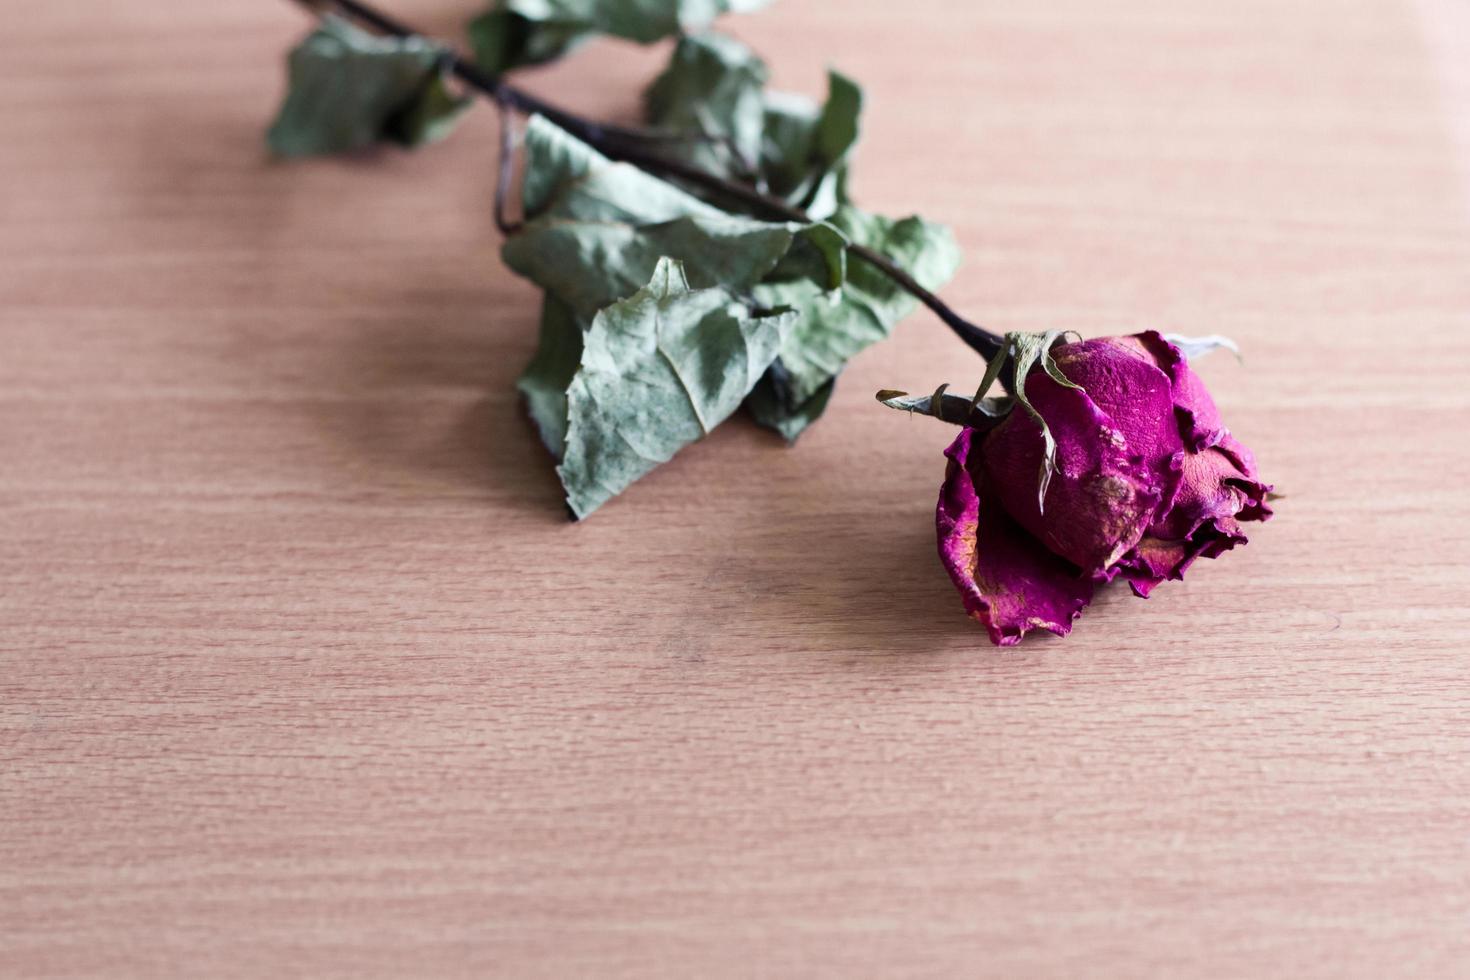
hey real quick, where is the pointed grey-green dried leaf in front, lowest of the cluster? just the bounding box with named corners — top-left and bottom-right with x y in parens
top-left (557, 260), bottom-right (795, 517)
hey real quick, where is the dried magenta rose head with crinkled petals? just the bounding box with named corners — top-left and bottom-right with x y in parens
top-left (934, 332), bottom-right (1272, 646)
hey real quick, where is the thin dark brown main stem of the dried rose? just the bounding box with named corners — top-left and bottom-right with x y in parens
top-left (285, 0), bottom-right (1005, 360)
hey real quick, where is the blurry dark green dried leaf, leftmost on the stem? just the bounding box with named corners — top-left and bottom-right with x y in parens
top-left (266, 18), bottom-right (469, 157)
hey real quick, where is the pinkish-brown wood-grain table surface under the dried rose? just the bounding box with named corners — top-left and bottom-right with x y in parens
top-left (0, 0), bottom-right (1470, 977)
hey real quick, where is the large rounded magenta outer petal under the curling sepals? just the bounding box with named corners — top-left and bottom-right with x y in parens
top-left (985, 338), bottom-right (1183, 579)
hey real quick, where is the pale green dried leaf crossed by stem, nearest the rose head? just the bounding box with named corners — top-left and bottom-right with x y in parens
top-left (754, 207), bottom-right (960, 433)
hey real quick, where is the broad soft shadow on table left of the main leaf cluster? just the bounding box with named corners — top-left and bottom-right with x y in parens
top-left (119, 100), bottom-right (566, 525)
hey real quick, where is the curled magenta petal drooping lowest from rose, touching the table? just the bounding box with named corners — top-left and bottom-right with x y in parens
top-left (935, 429), bottom-right (1092, 646)
